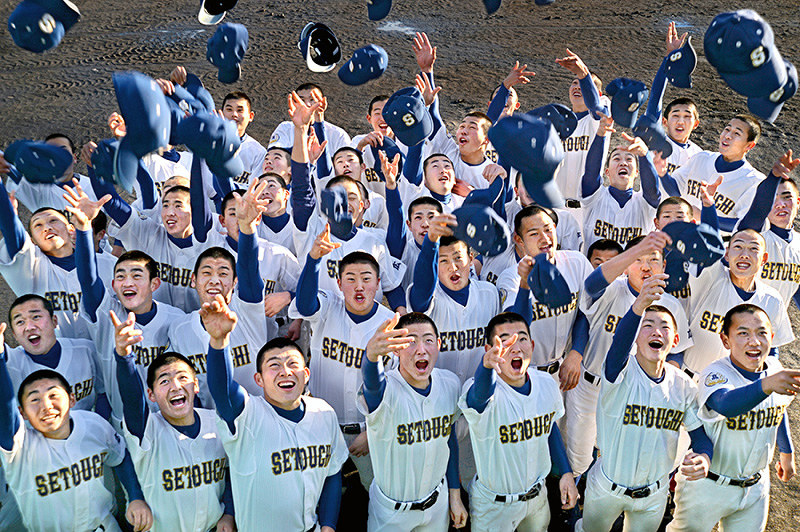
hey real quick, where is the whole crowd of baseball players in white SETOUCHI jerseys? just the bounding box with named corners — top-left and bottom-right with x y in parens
top-left (0, 25), bottom-right (800, 532)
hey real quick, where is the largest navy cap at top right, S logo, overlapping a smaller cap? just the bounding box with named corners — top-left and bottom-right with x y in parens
top-left (703, 9), bottom-right (787, 98)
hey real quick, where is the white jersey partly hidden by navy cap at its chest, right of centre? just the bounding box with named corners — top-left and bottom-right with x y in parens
top-left (497, 250), bottom-right (592, 366)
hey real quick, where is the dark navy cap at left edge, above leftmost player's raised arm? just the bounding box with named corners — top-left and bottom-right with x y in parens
top-left (3, 140), bottom-right (73, 183)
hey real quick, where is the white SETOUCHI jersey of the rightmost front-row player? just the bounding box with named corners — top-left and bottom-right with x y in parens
top-left (698, 356), bottom-right (794, 479)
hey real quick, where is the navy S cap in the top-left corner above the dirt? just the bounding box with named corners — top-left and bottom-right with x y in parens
top-left (8, 0), bottom-right (81, 53)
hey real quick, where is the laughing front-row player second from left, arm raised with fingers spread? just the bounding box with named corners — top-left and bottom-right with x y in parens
top-left (110, 310), bottom-right (234, 532)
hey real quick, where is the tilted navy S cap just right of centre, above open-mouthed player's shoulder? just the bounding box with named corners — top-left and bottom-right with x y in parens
top-left (453, 203), bottom-right (511, 257)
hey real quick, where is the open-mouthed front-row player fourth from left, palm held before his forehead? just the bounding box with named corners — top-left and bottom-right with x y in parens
top-left (358, 312), bottom-right (467, 532)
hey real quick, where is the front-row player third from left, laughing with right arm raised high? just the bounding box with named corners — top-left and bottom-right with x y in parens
top-left (201, 295), bottom-right (347, 532)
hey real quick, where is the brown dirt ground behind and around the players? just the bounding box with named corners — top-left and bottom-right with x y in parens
top-left (0, 0), bottom-right (800, 531)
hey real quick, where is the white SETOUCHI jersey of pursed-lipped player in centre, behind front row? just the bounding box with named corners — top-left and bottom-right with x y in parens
top-left (289, 290), bottom-right (394, 424)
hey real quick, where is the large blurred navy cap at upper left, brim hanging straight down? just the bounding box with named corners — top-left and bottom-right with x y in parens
top-left (112, 72), bottom-right (171, 192)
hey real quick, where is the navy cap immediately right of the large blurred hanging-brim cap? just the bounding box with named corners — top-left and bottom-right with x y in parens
top-left (176, 112), bottom-right (244, 178)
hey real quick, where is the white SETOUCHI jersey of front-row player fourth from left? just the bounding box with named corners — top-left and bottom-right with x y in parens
top-left (358, 368), bottom-right (461, 501)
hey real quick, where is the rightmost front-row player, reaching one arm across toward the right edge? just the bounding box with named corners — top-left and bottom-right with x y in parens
top-left (667, 303), bottom-right (800, 532)
